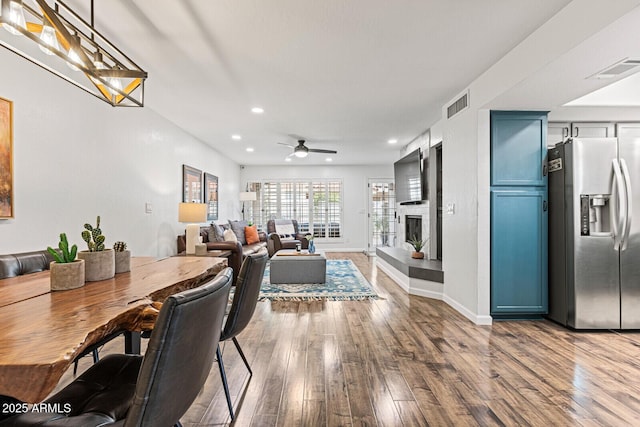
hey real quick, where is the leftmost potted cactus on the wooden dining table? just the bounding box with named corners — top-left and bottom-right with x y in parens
top-left (47, 233), bottom-right (84, 291)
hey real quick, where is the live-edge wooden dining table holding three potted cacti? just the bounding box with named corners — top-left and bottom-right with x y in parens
top-left (0, 257), bottom-right (226, 403)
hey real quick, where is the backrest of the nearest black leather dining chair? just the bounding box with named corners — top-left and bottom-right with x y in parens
top-left (124, 268), bottom-right (233, 427)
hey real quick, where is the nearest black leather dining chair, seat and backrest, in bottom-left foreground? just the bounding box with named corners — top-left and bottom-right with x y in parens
top-left (0, 268), bottom-right (233, 427)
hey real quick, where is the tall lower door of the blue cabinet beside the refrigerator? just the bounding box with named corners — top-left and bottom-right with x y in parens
top-left (491, 189), bottom-right (548, 317)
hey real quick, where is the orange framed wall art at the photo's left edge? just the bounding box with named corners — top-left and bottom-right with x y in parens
top-left (0, 98), bottom-right (14, 219)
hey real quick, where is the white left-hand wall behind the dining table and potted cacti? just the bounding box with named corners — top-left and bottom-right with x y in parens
top-left (0, 49), bottom-right (240, 257)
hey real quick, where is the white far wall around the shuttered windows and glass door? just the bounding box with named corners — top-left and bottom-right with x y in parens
top-left (240, 163), bottom-right (396, 251)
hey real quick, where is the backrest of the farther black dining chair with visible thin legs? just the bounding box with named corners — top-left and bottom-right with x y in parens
top-left (220, 249), bottom-right (269, 341)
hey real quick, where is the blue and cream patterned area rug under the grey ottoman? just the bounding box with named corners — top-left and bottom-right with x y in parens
top-left (259, 259), bottom-right (379, 301)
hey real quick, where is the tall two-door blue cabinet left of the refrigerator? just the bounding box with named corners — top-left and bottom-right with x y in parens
top-left (491, 111), bottom-right (548, 318)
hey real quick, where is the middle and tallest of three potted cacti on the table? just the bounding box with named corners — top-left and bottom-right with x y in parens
top-left (78, 215), bottom-right (116, 282)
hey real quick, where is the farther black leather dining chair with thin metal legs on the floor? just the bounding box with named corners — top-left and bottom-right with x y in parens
top-left (216, 250), bottom-right (269, 421)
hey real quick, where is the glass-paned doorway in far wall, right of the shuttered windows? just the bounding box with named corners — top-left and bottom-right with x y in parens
top-left (367, 179), bottom-right (396, 255)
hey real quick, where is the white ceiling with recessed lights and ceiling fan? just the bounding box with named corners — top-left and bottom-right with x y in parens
top-left (66, 0), bottom-right (569, 165)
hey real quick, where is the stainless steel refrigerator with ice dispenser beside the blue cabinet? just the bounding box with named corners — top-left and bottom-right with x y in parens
top-left (548, 138), bottom-right (640, 329)
